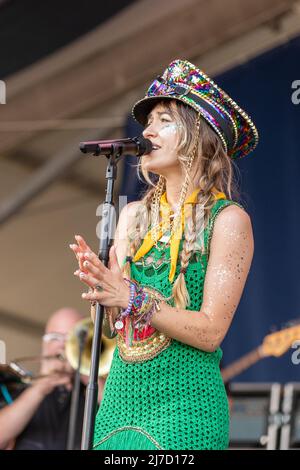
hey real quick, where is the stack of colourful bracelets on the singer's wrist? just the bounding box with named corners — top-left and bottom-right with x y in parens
top-left (113, 278), bottom-right (162, 347)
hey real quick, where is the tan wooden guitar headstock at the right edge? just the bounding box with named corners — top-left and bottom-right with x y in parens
top-left (260, 325), bottom-right (300, 357)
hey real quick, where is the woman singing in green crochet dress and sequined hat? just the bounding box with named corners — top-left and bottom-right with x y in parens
top-left (71, 60), bottom-right (258, 450)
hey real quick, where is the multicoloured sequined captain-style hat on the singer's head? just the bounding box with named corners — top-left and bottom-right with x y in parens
top-left (132, 59), bottom-right (258, 159)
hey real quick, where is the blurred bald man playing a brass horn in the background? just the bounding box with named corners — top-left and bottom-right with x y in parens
top-left (0, 308), bottom-right (85, 450)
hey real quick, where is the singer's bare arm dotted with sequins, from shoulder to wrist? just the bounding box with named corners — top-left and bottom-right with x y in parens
top-left (151, 206), bottom-right (254, 352)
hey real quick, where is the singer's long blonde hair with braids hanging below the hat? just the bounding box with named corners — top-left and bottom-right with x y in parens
top-left (123, 100), bottom-right (239, 309)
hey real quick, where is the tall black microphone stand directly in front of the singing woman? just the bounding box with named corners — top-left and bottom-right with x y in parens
top-left (81, 144), bottom-right (121, 450)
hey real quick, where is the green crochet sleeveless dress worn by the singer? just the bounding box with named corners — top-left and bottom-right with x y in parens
top-left (94, 199), bottom-right (241, 450)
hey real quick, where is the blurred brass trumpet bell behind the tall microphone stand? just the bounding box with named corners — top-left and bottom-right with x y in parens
top-left (65, 317), bottom-right (116, 377)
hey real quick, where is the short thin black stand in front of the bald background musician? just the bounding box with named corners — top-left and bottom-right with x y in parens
top-left (67, 328), bottom-right (88, 450)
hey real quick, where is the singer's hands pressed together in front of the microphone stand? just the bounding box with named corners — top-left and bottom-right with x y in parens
top-left (70, 235), bottom-right (129, 309)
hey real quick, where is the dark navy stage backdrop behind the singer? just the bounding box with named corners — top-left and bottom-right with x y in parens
top-left (122, 37), bottom-right (300, 382)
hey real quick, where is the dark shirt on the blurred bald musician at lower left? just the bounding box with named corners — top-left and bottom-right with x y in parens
top-left (15, 384), bottom-right (85, 450)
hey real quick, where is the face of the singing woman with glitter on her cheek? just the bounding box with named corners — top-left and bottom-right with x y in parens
top-left (142, 104), bottom-right (181, 177)
